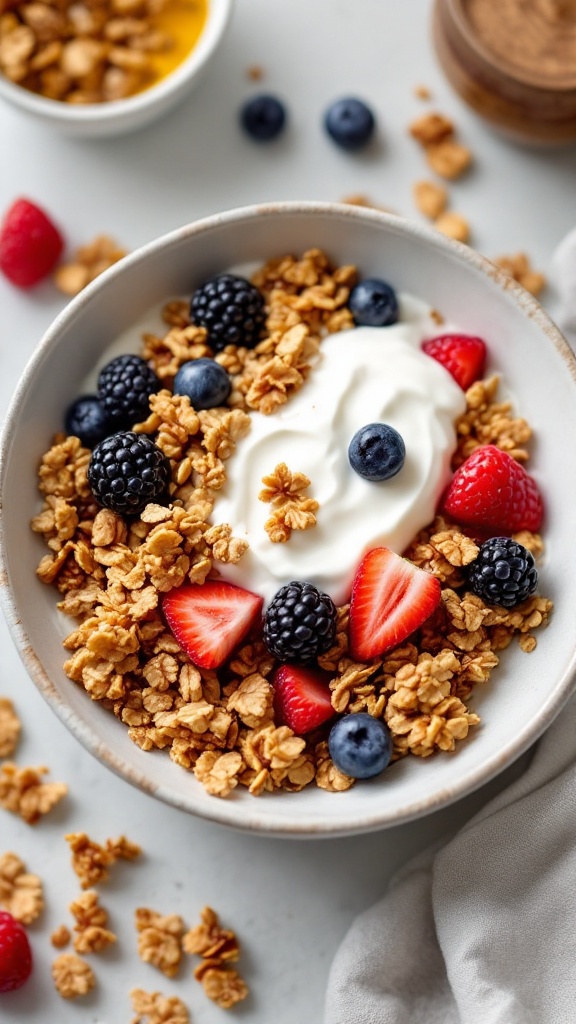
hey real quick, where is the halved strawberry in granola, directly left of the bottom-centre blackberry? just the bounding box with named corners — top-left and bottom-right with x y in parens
top-left (162, 580), bottom-right (262, 669)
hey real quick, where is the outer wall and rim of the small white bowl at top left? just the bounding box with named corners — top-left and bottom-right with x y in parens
top-left (0, 0), bottom-right (232, 138)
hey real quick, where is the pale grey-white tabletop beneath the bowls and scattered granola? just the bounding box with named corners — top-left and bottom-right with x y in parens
top-left (0, 0), bottom-right (576, 1024)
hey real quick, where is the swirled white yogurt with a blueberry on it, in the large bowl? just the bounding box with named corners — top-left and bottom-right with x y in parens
top-left (212, 296), bottom-right (465, 604)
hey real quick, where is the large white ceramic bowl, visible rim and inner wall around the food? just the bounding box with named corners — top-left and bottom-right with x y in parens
top-left (0, 203), bottom-right (576, 837)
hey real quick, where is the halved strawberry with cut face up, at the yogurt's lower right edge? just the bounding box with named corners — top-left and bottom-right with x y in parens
top-left (349, 548), bottom-right (440, 662)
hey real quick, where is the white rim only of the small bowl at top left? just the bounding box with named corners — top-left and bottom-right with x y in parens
top-left (0, 0), bottom-right (234, 130)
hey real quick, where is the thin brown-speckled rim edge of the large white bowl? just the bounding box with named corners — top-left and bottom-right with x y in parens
top-left (0, 195), bottom-right (576, 839)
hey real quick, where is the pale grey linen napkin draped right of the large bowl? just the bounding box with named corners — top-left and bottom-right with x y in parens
top-left (325, 230), bottom-right (576, 1024)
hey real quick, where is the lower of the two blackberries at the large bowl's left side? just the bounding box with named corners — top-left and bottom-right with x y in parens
top-left (88, 430), bottom-right (170, 515)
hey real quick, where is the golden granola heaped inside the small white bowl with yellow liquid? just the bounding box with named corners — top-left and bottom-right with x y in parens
top-left (0, 0), bottom-right (201, 103)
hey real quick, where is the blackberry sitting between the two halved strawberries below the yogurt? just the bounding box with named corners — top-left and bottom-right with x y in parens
top-left (263, 580), bottom-right (336, 665)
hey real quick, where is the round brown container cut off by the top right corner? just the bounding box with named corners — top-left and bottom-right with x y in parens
top-left (433, 0), bottom-right (576, 143)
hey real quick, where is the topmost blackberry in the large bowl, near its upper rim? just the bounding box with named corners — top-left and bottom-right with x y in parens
top-left (190, 273), bottom-right (265, 352)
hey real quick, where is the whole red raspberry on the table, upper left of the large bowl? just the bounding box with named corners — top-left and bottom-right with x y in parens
top-left (0, 199), bottom-right (64, 288)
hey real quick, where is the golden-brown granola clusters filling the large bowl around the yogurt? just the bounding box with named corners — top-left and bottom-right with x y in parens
top-left (32, 251), bottom-right (551, 794)
